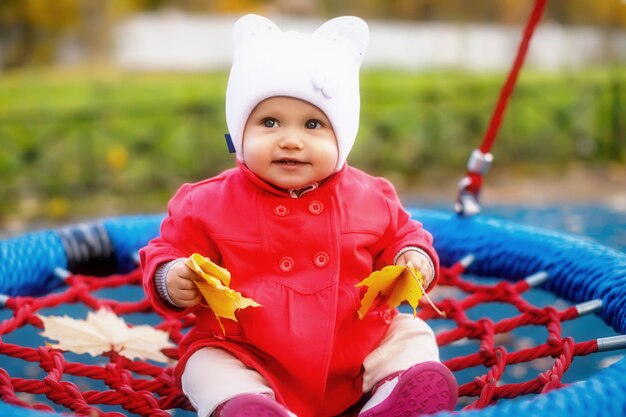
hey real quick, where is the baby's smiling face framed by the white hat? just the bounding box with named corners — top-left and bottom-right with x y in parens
top-left (243, 97), bottom-right (339, 189)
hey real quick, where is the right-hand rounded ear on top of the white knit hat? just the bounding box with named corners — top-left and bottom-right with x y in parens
top-left (314, 16), bottom-right (370, 63)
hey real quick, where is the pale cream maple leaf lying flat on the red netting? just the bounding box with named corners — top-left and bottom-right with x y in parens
top-left (38, 308), bottom-right (174, 362)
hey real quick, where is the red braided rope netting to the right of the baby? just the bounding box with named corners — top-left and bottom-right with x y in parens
top-left (420, 263), bottom-right (598, 409)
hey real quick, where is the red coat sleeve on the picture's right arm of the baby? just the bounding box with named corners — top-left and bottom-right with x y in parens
top-left (374, 178), bottom-right (439, 290)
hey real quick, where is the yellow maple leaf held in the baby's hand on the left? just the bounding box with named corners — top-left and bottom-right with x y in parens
top-left (187, 253), bottom-right (261, 333)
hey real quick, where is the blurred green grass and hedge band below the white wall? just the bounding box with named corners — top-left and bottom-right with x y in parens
top-left (0, 70), bottom-right (626, 229)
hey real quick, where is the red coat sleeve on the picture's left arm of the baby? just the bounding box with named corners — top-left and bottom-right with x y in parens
top-left (139, 184), bottom-right (219, 315)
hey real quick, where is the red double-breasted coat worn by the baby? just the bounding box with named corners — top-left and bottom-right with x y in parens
top-left (141, 165), bottom-right (439, 417)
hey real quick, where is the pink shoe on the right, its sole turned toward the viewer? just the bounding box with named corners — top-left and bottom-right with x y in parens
top-left (359, 362), bottom-right (459, 417)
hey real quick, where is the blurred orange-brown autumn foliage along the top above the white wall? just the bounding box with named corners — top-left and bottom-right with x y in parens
top-left (0, 0), bottom-right (626, 69)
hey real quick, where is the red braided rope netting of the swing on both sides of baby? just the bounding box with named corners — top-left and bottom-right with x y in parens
top-left (0, 256), bottom-right (598, 417)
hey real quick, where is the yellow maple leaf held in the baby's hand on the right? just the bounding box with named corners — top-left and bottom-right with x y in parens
top-left (356, 265), bottom-right (424, 319)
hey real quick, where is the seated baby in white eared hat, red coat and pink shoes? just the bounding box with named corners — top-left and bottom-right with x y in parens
top-left (141, 15), bottom-right (457, 417)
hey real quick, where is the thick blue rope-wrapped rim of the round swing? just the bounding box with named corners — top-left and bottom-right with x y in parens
top-left (0, 209), bottom-right (626, 417)
